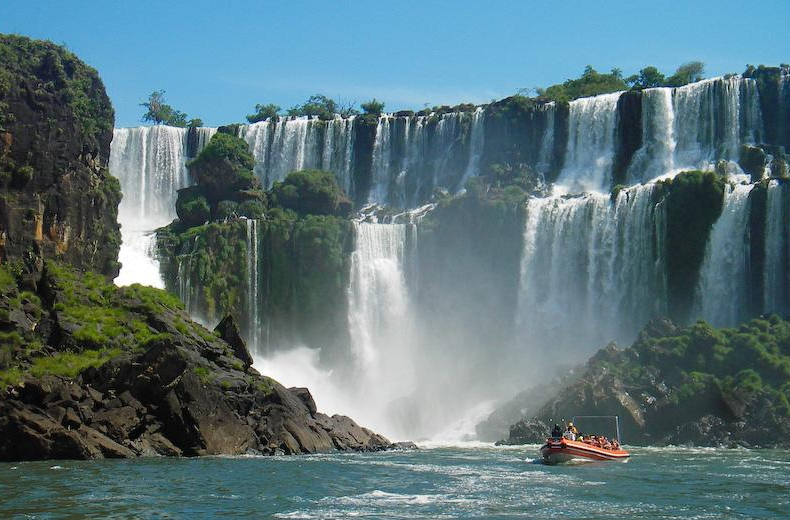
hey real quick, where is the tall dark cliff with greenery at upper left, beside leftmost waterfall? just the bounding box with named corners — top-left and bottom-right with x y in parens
top-left (0, 36), bottom-right (120, 277)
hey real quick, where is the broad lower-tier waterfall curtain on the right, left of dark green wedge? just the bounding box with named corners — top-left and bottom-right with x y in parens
top-left (517, 185), bottom-right (666, 361)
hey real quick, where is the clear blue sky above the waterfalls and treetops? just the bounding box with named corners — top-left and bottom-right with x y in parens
top-left (0, 0), bottom-right (790, 126)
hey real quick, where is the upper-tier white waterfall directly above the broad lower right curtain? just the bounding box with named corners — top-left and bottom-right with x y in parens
top-left (557, 92), bottom-right (622, 193)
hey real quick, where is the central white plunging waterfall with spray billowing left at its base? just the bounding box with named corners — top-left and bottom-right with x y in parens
top-left (260, 222), bottom-right (419, 437)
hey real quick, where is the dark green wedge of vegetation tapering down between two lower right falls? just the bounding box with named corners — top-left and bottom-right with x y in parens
top-left (661, 171), bottom-right (725, 322)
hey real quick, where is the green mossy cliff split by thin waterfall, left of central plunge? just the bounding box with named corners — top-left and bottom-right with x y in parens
top-left (157, 167), bottom-right (353, 345)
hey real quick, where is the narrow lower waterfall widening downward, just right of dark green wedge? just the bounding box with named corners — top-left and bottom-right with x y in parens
top-left (695, 184), bottom-right (753, 327)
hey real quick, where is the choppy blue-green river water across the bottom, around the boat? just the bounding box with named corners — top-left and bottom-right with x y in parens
top-left (0, 445), bottom-right (790, 520)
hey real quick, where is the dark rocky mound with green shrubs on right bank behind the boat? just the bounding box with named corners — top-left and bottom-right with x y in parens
top-left (506, 316), bottom-right (790, 447)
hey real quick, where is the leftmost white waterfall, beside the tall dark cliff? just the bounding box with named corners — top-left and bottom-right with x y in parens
top-left (109, 126), bottom-right (188, 287)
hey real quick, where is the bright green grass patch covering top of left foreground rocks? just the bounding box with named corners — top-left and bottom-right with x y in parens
top-left (0, 261), bottom-right (201, 387)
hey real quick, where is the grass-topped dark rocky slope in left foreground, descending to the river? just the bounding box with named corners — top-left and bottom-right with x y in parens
top-left (0, 261), bottom-right (390, 460)
